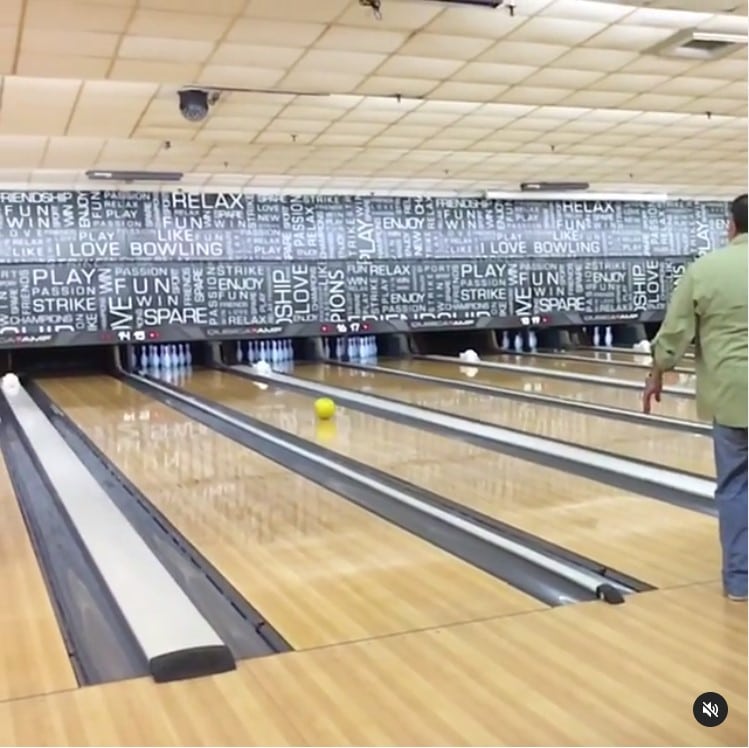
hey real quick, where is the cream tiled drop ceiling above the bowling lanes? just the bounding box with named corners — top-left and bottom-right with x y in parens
top-left (0, 0), bottom-right (747, 196)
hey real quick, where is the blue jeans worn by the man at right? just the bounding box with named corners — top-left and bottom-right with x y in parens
top-left (713, 423), bottom-right (747, 596)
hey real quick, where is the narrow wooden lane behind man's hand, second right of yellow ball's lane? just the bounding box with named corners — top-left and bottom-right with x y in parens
top-left (380, 359), bottom-right (699, 421)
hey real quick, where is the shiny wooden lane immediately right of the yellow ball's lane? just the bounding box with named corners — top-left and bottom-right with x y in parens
top-left (294, 364), bottom-right (715, 477)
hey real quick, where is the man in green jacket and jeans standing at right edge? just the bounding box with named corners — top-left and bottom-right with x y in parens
top-left (642, 195), bottom-right (748, 601)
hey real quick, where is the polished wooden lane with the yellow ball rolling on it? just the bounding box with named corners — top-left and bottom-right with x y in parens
top-left (183, 367), bottom-right (719, 586)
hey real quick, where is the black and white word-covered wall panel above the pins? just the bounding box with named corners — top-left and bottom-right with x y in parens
top-left (0, 192), bottom-right (727, 346)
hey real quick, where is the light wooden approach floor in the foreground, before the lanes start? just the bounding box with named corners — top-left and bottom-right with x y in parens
top-left (0, 585), bottom-right (747, 746)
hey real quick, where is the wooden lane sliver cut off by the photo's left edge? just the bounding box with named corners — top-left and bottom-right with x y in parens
top-left (0, 457), bottom-right (76, 701)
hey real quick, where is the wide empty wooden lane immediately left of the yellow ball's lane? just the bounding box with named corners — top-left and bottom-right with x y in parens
top-left (41, 377), bottom-right (543, 648)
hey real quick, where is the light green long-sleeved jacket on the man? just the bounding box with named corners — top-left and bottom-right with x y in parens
top-left (652, 234), bottom-right (749, 428)
